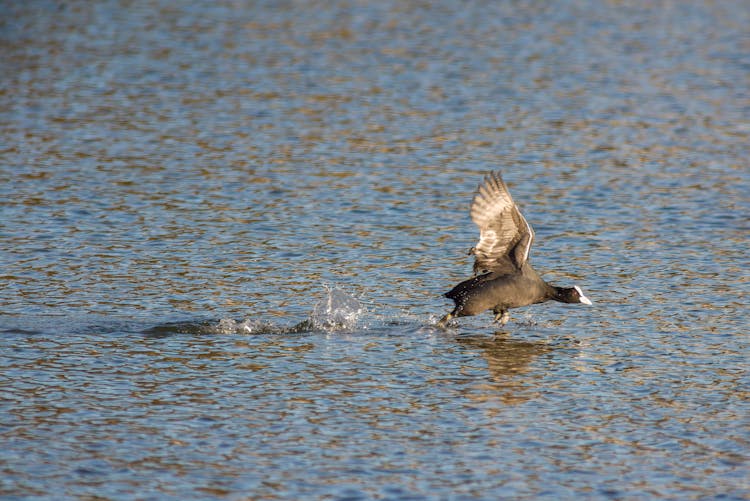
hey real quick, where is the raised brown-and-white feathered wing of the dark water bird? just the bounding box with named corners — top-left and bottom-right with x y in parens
top-left (471, 172), bottom-right (534, 274)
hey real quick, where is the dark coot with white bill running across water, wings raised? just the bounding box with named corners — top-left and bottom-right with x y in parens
top-left (438, 172), bottom-right (591, 327)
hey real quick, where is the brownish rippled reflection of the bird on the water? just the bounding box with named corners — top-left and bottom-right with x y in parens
top-left (456, 331), bottom-right (554, 404)
